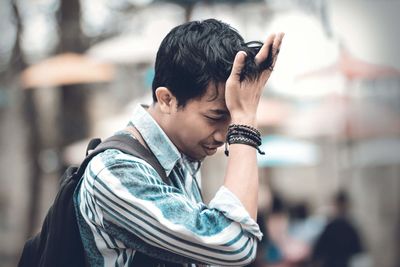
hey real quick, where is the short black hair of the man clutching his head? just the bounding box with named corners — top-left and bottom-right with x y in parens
top-left (152, 19), bottom-right (272, 107)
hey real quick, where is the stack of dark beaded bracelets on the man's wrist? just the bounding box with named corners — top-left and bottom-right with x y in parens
top-left (225, 124), bottom-right (265, 156)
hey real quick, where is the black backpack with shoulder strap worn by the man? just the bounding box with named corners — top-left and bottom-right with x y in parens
top-left (18, 135), bottom-right (182, 267)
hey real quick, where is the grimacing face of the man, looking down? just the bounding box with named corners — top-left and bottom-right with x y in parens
top-left (169, 84), bottom-right (230, 160)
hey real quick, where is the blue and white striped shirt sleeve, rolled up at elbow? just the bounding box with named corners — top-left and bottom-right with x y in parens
top-left (84, 150), bottom-right (262, 266)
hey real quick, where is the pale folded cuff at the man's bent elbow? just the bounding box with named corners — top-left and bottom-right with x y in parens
top-left (209, 186), bottom-right (263, 240)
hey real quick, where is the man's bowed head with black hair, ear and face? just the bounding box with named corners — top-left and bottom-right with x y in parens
top-left (148, 19), bottom-right (261, 160)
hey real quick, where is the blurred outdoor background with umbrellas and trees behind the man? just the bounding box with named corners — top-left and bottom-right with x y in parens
top-left (0, 0), bottom-right (400, 267)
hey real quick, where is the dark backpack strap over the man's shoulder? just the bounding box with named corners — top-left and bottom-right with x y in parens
top-left (76, 134), bottom-right (170, 185)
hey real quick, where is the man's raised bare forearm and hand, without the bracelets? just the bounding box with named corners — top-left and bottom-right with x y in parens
top-left (224, 33), bottom-right (284, 219)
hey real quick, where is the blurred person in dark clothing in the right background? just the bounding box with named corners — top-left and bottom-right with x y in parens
top-left (313, 191), bottom-right (363, 267)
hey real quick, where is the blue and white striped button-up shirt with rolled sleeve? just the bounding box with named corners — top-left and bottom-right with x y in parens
top-left (75, 106), bottom-right (262, 266)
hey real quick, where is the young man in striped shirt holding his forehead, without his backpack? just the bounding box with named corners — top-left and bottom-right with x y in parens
top-left (76, 19), bottom-right (283, 266)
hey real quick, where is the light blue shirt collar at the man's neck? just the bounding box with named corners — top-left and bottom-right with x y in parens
top-left (130, 105), bottom-right (182, 176)
